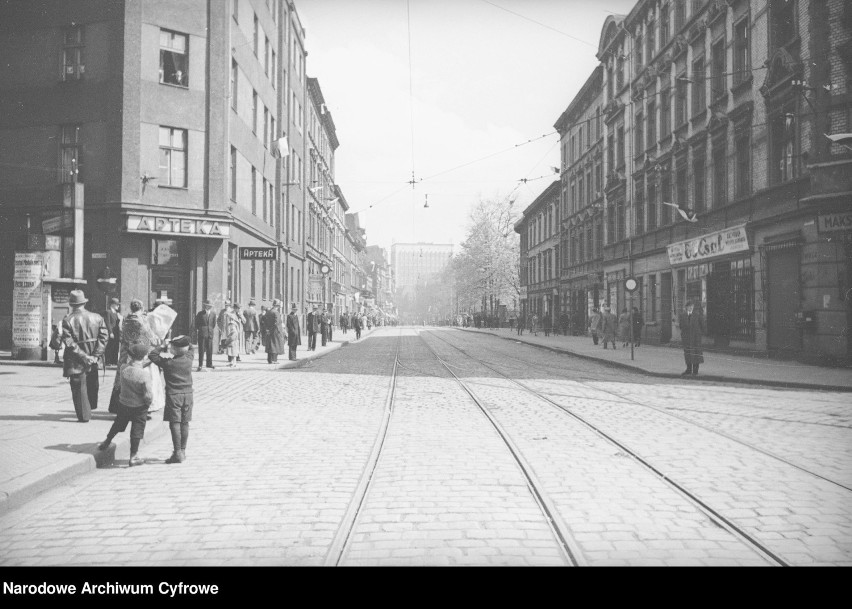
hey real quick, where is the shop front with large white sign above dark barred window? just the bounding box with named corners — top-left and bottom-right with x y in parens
top-left (668, 224), bottom-right (756, 349)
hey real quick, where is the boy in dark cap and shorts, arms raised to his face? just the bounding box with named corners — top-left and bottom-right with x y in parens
top-left (148, 336), bottom-right (195, 463)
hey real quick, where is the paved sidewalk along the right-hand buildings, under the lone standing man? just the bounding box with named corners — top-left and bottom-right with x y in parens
top-left (459, 328), bottom-right (852, 391)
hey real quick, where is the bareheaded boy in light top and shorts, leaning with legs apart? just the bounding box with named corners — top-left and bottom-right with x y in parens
top-left (98, 342), bottom-right (154, 467)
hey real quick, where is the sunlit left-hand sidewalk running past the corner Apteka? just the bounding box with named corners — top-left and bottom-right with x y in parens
top-left (0, 328), bottom-right (375, 517)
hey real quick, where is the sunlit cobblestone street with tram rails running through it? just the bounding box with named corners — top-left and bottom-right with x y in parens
top-left (0, 327), bottom-right (852, 566)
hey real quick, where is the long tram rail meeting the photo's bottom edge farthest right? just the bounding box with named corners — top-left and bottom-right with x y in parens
top-left (424, 331), bottom-right (792, 566)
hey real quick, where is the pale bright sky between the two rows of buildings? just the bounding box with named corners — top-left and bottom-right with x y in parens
top-left (296, 0), bottom-right (635, 256)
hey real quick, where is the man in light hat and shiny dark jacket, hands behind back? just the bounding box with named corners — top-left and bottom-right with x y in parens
top-left (62, 290), bottom-right (109, 423)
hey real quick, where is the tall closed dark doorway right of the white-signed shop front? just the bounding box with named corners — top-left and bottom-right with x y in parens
top-left (767, 248), bottom-right (802, 351)
